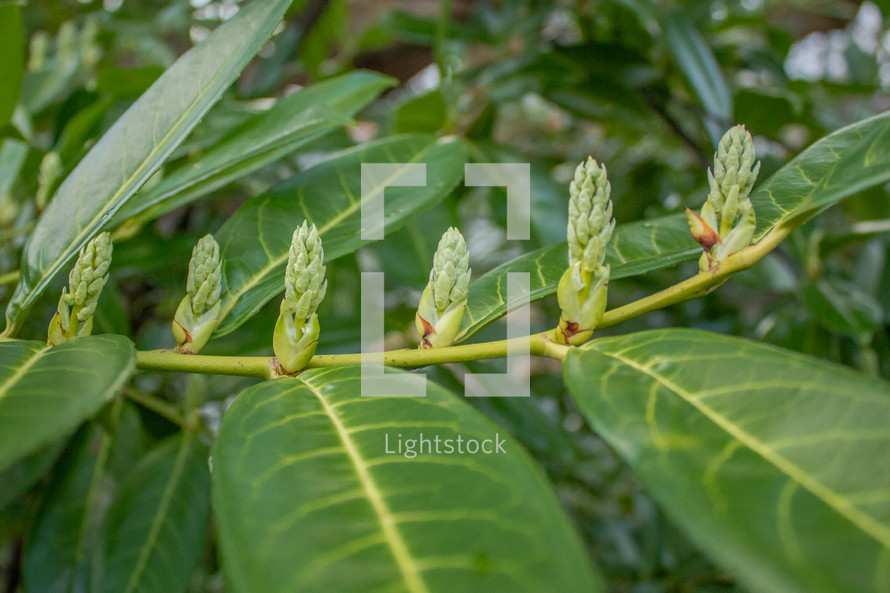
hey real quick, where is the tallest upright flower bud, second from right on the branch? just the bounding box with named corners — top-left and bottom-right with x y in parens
top-left (556, 157), bottom-right (615, 344)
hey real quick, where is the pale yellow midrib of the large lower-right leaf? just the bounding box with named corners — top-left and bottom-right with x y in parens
top-left (597, 350), bottom-right (890, 548)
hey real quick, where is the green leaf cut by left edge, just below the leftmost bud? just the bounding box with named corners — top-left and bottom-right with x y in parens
top-left (0, 335), bottom-right (136, 470)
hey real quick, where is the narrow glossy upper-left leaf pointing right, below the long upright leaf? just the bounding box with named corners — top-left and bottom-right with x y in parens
top-left (110, 71), bottom-right (395, 226)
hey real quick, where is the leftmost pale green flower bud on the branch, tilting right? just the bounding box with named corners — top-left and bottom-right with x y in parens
top-left (47, 233), bottom-right (113, 346)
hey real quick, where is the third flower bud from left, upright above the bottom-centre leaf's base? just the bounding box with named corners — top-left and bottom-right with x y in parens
top-left (272, 221), bottom-right (328, 375)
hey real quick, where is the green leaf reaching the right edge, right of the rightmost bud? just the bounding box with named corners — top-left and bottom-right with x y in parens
top-left (751, 112), bottom-right (890, 239)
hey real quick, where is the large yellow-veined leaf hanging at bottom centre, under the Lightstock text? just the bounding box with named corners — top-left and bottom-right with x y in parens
top-left (213, 366), bottom-right (599, 593)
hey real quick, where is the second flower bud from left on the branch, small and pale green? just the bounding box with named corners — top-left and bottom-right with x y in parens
top-left (173, 234), bottom-right (222, 354)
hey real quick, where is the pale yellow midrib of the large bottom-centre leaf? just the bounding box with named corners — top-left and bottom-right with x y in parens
top-left (300, 379), bottom-right (430, 593)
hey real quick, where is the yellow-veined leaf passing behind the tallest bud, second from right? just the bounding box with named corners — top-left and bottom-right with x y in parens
top-left (456, 215), bottom-right (701, 342)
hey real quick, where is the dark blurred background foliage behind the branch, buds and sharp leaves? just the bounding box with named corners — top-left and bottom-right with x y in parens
top-left (0, 0), bottom-right (890, 593)
